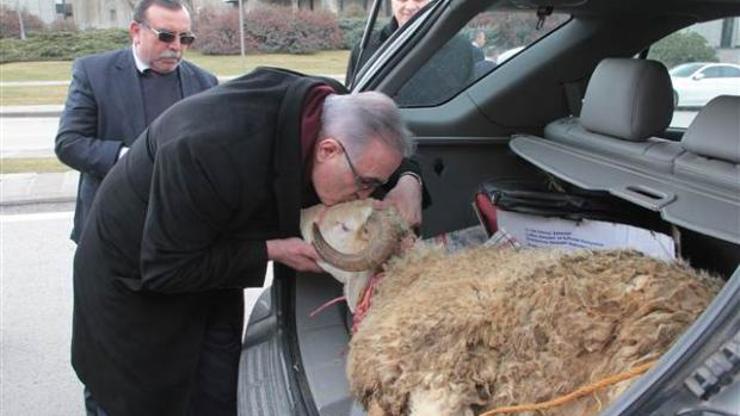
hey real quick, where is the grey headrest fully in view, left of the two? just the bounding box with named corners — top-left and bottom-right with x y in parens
top-left (581, 58), bottom-right (673, 142)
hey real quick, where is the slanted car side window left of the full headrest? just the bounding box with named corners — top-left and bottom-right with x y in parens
top-left (394, 11), bottom-right (569, 107)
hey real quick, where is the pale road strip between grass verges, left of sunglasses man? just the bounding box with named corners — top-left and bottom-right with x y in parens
top-left (0, 117), bottom-right (59, 158)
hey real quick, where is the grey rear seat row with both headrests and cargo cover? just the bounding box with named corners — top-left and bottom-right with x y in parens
top-left (509, 59), bottom-right (740, 244)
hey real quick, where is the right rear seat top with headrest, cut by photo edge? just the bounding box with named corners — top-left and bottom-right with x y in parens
top-left (673, 95), bottom-right (740, 191)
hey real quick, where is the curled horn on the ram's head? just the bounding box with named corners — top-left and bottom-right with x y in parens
top-left (312, 208), bottom-right (406, 272)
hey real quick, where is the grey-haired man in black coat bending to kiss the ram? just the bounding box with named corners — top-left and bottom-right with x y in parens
top-left (72, 69), bottom-right (421, 416)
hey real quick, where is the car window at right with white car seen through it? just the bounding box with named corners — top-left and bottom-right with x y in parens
top-left (648, 16), bottom-right (740, 128)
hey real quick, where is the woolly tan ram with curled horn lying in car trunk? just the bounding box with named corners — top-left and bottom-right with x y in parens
top-left (302, 202), bottom-right (721, 416)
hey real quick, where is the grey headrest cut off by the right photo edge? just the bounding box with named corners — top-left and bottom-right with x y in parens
top-left (681, 95), bottom-right (740, 163)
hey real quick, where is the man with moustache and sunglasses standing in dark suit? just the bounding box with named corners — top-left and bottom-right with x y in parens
top-left (55, 0), bottom-right (217, 242)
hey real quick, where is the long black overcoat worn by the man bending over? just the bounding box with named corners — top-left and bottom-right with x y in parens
top-left (72, 68), bottom-right (343, 416)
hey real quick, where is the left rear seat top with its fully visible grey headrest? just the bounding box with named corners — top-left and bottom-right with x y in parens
top-left (545, 58), bottom-right (684, 173)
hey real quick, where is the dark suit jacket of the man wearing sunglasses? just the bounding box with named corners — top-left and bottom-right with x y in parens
top-left (55, 48), bottom-right (217, 241)
